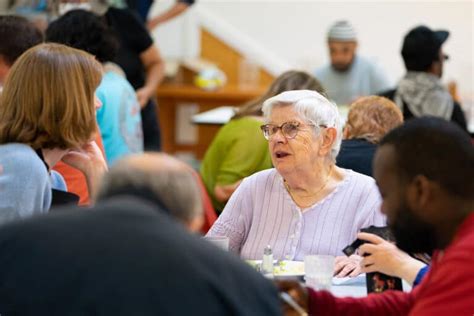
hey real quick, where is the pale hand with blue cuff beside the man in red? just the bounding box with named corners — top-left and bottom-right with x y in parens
top-left (357, 233), bottom-right (425, 284)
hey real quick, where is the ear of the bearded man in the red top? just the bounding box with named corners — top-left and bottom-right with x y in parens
top-left (406, 175), bottom-right (435, 215)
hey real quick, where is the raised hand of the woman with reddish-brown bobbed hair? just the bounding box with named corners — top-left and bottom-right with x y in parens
top-left (62, 141), bottom-right (107, 197)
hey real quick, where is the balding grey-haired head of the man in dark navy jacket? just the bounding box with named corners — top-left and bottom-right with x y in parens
top-left (97, 153), bottom-right (203, 232)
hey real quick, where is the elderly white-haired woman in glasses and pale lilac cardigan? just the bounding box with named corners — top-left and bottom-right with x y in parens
top-left (208, 90), bottom-right (385, 276)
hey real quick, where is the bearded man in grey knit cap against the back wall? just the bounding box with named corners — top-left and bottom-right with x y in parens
top-left (315, 21), bottom-right (390, 105)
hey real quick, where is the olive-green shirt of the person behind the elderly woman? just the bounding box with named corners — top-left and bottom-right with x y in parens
top-left (200, 117), bottom-right (272, 212)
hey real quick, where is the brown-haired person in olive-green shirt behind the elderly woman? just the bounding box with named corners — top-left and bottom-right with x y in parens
top-left (200, 71), bottom-right (323, 213)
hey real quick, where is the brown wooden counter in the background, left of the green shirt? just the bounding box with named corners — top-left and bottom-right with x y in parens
top-left (157, 84), bottom-right (266, 159)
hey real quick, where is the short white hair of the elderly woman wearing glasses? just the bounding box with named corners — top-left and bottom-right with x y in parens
top-left (262, 90), bottom-right (342, 161)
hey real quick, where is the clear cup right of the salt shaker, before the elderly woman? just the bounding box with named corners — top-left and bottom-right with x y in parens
top-left (304, 255), bottom-right (335, 291)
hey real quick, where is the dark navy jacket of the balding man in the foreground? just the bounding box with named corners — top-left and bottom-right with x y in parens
top-left (0, 197), bottom-right (281, 316)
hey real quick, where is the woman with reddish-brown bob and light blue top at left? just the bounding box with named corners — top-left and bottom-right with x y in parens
top-left (0, 44), bottom-right (107, 224)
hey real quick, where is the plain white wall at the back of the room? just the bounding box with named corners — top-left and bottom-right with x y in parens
top-left (150, 0), bottom-right (474, 101)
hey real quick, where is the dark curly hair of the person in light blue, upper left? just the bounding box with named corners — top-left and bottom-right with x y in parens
top-left (46, 10), bottom-right (119, 63)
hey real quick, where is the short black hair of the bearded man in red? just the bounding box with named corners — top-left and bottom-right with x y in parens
top-left (380, 117), bottom-right (474, 198)
